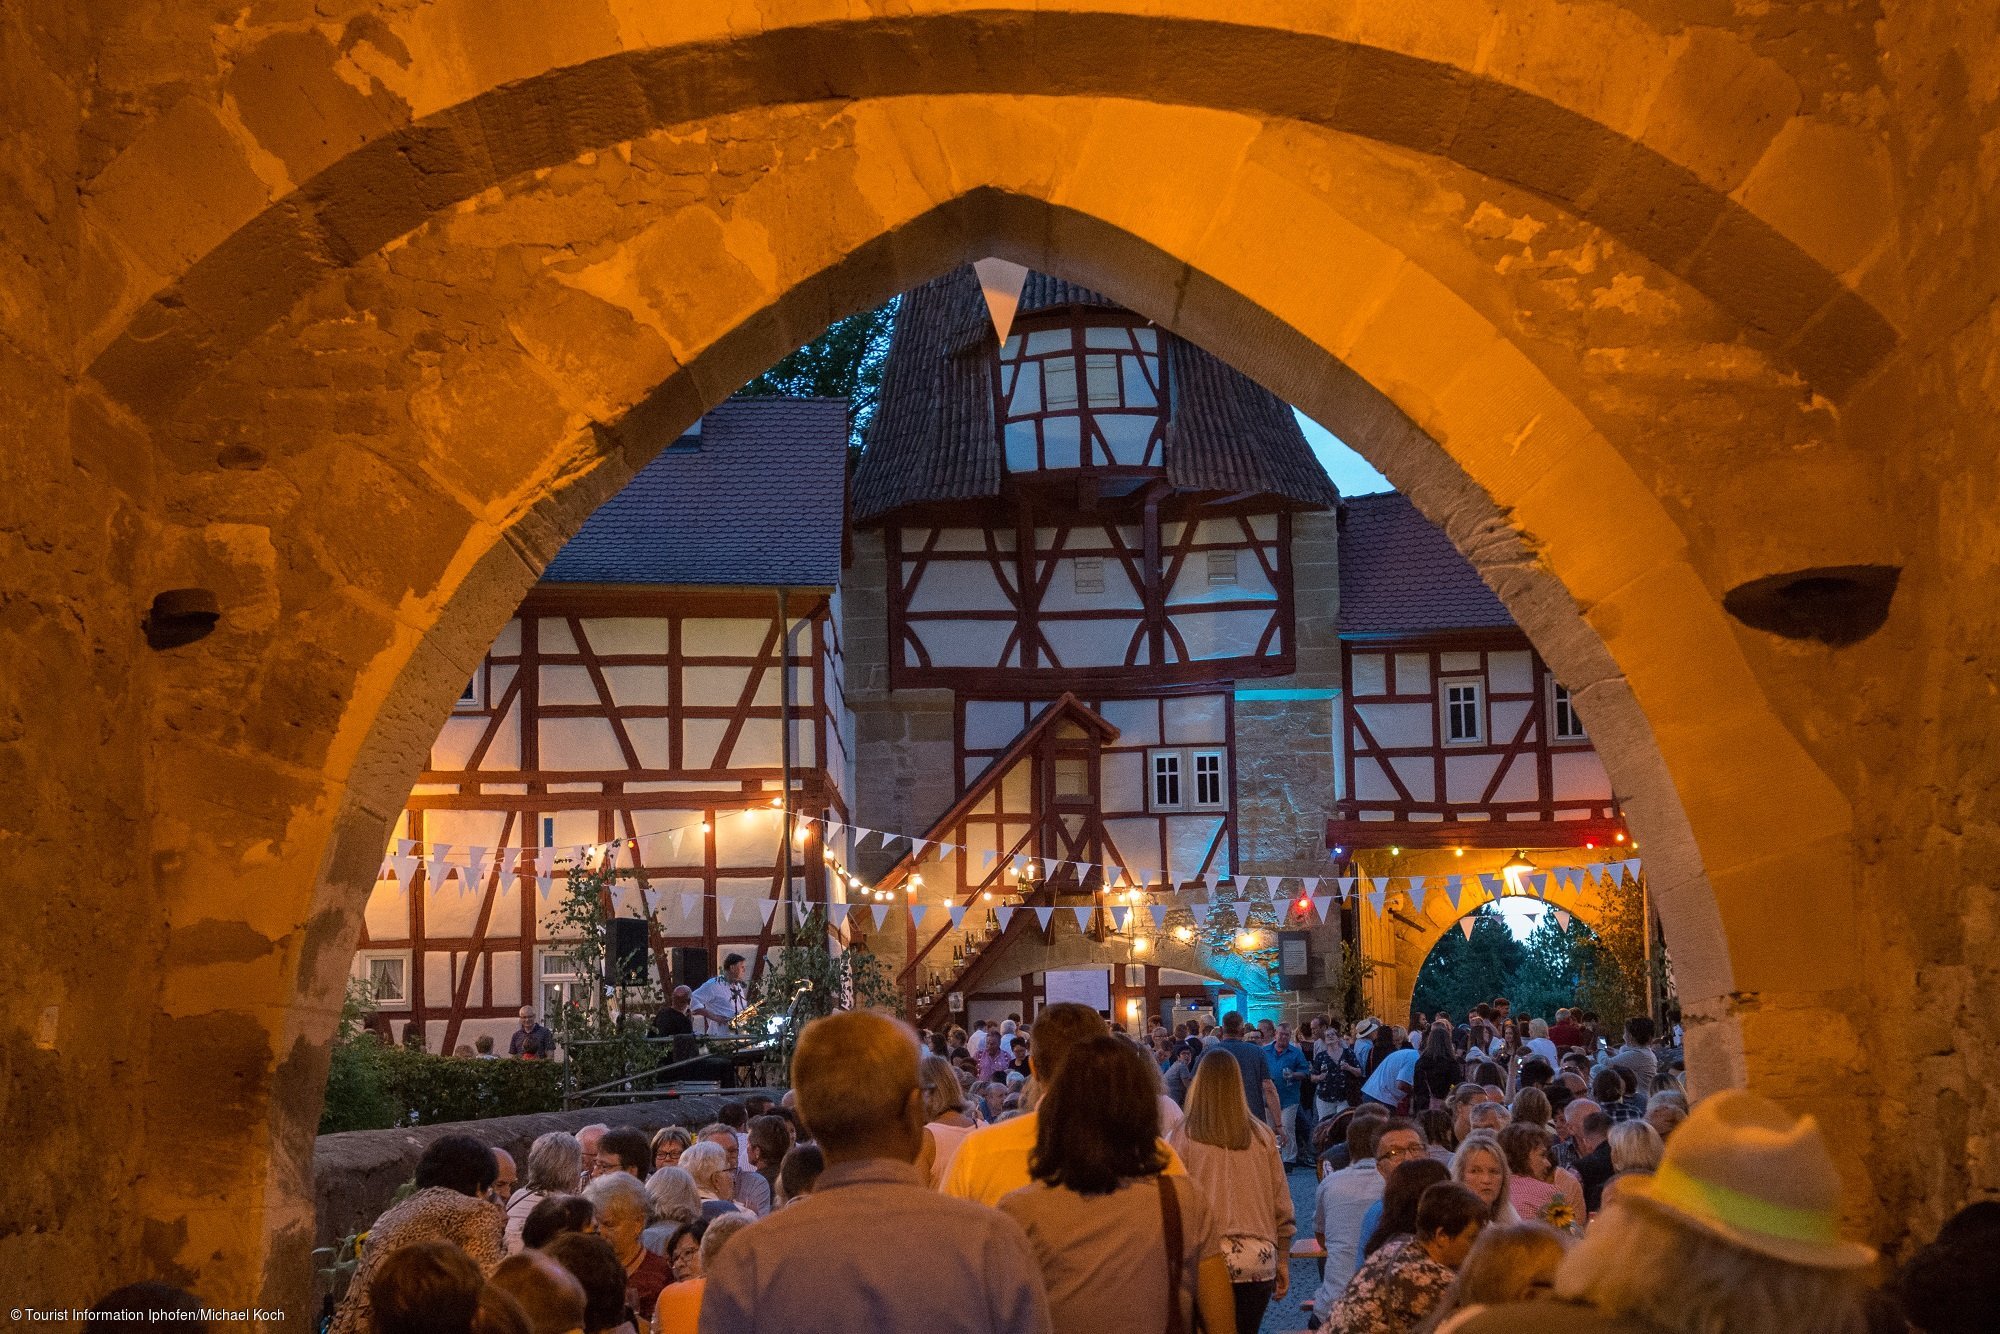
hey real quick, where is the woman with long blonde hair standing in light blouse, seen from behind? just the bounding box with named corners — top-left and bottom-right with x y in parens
top-left (1166, 1052), bottom-right (1294, 1334)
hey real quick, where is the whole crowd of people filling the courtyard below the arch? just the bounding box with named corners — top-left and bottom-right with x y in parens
top-left (94, 1002), bottom-right (2000, 1334)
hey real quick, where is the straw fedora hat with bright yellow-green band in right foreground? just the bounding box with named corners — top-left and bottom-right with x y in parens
top-left (1618, 1090), bottom-right (1876, 1268)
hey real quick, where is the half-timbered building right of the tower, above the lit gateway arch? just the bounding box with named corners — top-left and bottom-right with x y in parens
top-left (1326, 492), bottom-right (1628, 1014)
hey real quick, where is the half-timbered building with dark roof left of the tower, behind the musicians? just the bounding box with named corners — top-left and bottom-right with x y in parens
top-left (354, 398), bottom-right (848, 1050)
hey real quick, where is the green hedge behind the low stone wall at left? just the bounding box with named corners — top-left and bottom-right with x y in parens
top-left (320, 1034), bottom-right (562, 1134)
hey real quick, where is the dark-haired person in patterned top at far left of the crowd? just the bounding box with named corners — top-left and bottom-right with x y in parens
top-left (328, 1134), bottom-right (506, 1334)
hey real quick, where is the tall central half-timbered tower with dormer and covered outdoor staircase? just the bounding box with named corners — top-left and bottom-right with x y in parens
top-left (844, 270), bottom-right (1340, 1022)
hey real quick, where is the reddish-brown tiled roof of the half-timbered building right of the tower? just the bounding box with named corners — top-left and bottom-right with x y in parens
top-left (1340, 492), bottom-right (1514, 634)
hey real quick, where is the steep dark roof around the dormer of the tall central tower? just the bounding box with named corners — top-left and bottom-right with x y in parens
top-left (854, 266), bottom-right (1340, 522)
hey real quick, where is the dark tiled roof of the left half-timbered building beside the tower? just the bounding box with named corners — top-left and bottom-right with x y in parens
top-left (542, 398), bottom-right (848, 588)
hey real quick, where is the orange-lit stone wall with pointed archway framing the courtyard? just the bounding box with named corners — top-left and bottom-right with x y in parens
top-left (0, 0), bottom-right (2000, 1306)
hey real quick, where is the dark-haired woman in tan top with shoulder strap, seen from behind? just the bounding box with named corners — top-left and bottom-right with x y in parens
top-left (1000, 1036), bottom-right (1236, 1334)
